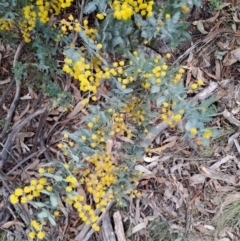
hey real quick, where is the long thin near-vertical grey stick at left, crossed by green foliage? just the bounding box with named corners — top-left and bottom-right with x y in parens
top-left (0, 41), bottom-right (25, 140)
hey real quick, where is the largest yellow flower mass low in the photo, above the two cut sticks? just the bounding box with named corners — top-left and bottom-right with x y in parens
top-left (61, 153), bottom-right (116, 231)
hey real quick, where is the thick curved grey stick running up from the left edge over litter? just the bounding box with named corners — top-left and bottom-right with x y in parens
top-left (0, 108), bottom-right (46, 169)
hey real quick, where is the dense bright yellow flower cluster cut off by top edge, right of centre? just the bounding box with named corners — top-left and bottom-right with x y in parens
top-left (112, 0), bottom-right (154, 20)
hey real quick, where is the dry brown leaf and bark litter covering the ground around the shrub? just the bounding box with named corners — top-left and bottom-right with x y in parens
top-left (0, 1), bottom-right (240, 241)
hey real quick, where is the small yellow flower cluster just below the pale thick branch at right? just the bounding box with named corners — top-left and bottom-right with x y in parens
top-left (161, 102), bottom-right (184, 127)
